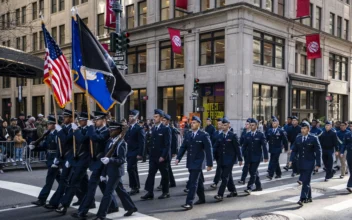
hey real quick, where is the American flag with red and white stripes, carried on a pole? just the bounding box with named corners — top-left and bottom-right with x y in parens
top-left (42, 24), bottom-right (72, 108)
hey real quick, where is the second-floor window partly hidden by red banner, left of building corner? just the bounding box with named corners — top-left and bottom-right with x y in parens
top-left (159, 39), bottom-right (184, 70)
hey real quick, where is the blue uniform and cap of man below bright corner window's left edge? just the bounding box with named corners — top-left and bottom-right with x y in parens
top-left (242, 119), bottom-right (268, 194)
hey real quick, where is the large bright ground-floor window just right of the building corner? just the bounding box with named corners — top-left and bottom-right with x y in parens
top-left (252, 84), bottom-right (285, 120)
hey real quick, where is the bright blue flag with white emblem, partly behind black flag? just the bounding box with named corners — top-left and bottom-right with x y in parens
top-left (72, 18), bottom-right (116, 112)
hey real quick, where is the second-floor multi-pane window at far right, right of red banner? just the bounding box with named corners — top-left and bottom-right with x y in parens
top-left (329, 53), bottom-right (348, 81)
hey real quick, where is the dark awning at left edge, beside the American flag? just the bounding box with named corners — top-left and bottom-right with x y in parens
top-left (0, 46), bottom-right (44, 78)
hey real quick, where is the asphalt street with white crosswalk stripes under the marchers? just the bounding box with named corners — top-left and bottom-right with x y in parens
top-left (0, 154), bottom-right (352, 220)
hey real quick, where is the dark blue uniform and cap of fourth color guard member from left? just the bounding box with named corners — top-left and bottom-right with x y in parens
top-left (78, 111), bottom-right (118, 216)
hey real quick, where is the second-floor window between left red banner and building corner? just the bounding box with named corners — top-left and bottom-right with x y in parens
top-left (199, 31), bottom-right (225, 66)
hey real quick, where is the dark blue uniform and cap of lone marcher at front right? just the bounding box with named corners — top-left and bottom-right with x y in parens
top-left (291, 122), bottom-right (321, 205)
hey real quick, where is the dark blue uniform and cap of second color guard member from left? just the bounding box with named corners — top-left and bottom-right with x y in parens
top-left (49, 109), bottom-right (73, 209)
